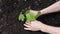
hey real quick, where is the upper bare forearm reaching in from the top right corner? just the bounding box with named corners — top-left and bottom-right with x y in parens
top-left (41, 1), bottom-right (60, 15)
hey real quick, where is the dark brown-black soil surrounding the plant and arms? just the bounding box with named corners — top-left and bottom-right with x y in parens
top-left (0, 0), bottom-right (60, 34)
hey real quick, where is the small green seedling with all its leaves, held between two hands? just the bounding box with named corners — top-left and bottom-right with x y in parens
top-left (18, 10), bottom-right (40, 21)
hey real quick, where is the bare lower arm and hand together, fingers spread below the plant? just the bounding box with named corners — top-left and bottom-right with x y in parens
top-left (24, 21), bottom-right (60, 34)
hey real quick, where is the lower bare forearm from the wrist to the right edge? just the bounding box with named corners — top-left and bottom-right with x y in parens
top-left (40, 24), bottom-right (60, 34)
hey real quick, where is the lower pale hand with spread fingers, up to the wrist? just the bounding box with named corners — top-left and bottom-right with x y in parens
top-left (24, 21), bottom-right (43, 31)
